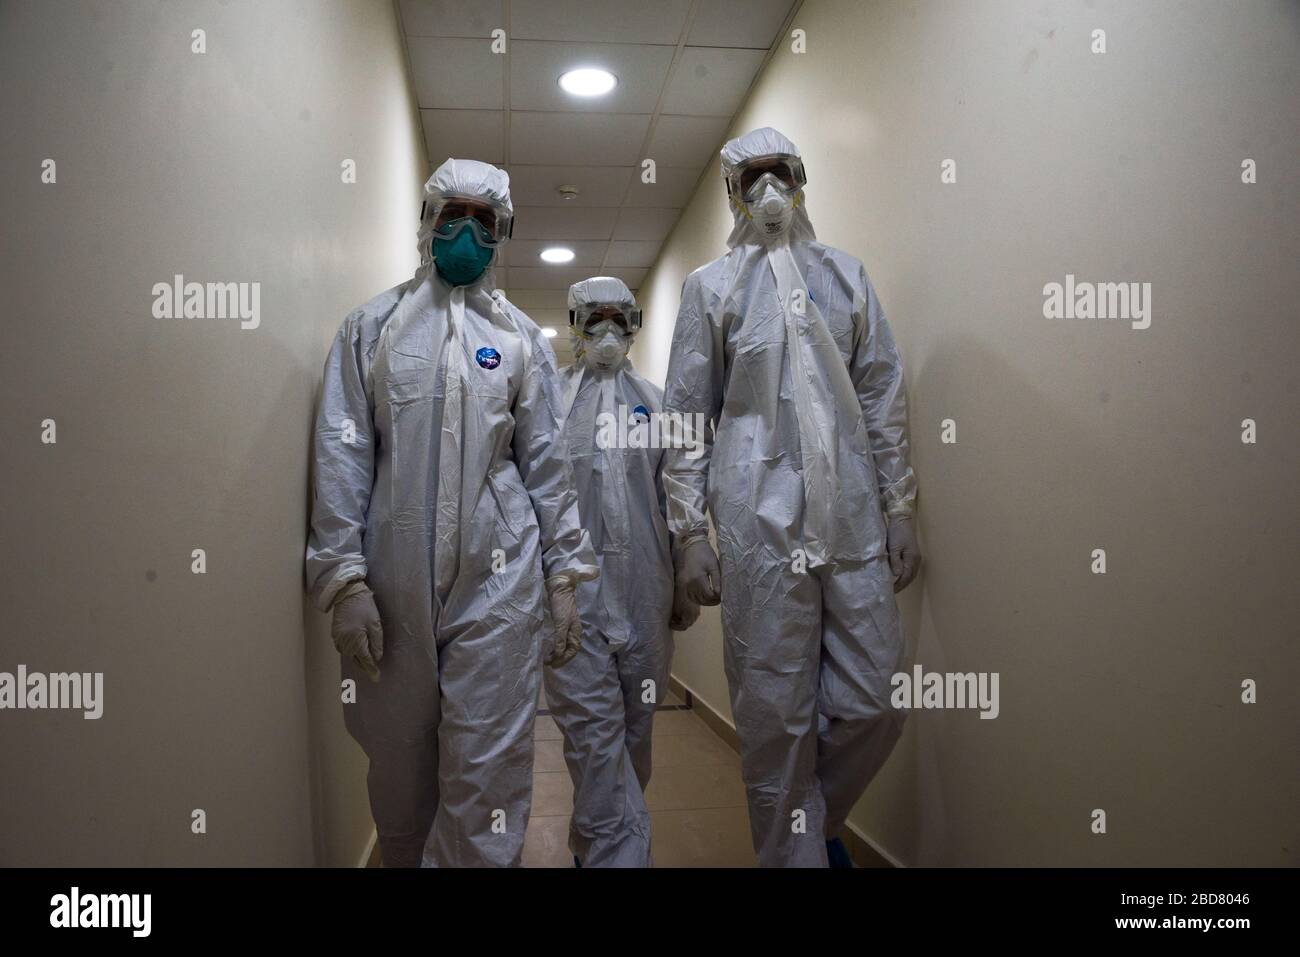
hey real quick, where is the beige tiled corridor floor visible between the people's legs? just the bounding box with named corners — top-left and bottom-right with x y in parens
top-left (524, 696), bottom-right (754, 867)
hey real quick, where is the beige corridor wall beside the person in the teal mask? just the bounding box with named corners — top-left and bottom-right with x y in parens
top-left (0, 0), bottom-right (425, 865)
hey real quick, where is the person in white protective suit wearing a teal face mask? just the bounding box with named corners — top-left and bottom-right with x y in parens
top-left (307, 160), bottom-right (598, 867)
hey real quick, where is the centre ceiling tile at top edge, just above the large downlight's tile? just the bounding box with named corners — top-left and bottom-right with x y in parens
top-left (510, 0), bottom-right (696, 46)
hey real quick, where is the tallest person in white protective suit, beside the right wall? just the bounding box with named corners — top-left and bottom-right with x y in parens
top-left (664, 127), bottom-right (920, 867)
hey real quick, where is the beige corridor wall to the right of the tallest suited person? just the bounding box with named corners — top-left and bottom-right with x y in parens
top-left (633, 0), bottom-right (1300, 865)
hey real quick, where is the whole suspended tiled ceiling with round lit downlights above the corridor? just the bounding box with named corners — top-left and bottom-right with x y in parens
top-left (398, 0), bottom-right (797, 360)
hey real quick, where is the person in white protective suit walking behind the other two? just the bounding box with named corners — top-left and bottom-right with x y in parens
top-left (546, 277), bottom-right (699, 867)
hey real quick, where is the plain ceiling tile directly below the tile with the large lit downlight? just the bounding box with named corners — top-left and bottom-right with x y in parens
top-left (510, 111), bottom-right (650, 166)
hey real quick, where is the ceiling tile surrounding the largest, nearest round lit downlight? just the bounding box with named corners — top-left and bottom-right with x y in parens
top-left (510, 40), bottom-right (673, 113)
